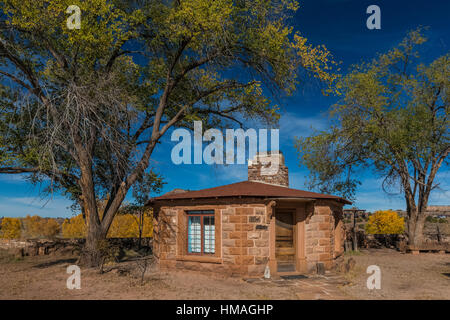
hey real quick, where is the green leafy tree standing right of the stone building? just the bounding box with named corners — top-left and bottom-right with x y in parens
top-left (296, 29), bottom-right (450, 244)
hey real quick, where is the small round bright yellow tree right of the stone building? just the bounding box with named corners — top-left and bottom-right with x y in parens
top-left (366, 210), bottom-right (405, 234)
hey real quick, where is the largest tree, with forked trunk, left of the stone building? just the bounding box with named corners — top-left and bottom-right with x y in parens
top-left (0, 0), bottom-right (336, 266)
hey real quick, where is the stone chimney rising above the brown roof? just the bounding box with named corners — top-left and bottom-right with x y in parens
top-left (248, 152), bottom-right (289, 187)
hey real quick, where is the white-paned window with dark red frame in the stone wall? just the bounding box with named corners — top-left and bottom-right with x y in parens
top-left (187, 210), bottom-right (216, 254)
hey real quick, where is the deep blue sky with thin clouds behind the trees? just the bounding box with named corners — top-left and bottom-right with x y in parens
top-left (0, 0), bottom-right (450, 217)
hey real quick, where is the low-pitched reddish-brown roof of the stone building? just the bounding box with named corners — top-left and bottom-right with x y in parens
top-left (149, 181), bottom-right (351, 204)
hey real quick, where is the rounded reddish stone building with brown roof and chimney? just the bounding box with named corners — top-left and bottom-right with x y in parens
top-left (148, 153), bottom-right (350, 276)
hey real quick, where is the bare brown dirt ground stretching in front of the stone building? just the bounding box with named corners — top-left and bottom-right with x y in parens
top-left (0, 250), bottom-right (450, 300)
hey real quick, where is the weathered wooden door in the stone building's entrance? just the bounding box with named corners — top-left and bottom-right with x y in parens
top-left (275, 210), bottom-right (295, 271)
